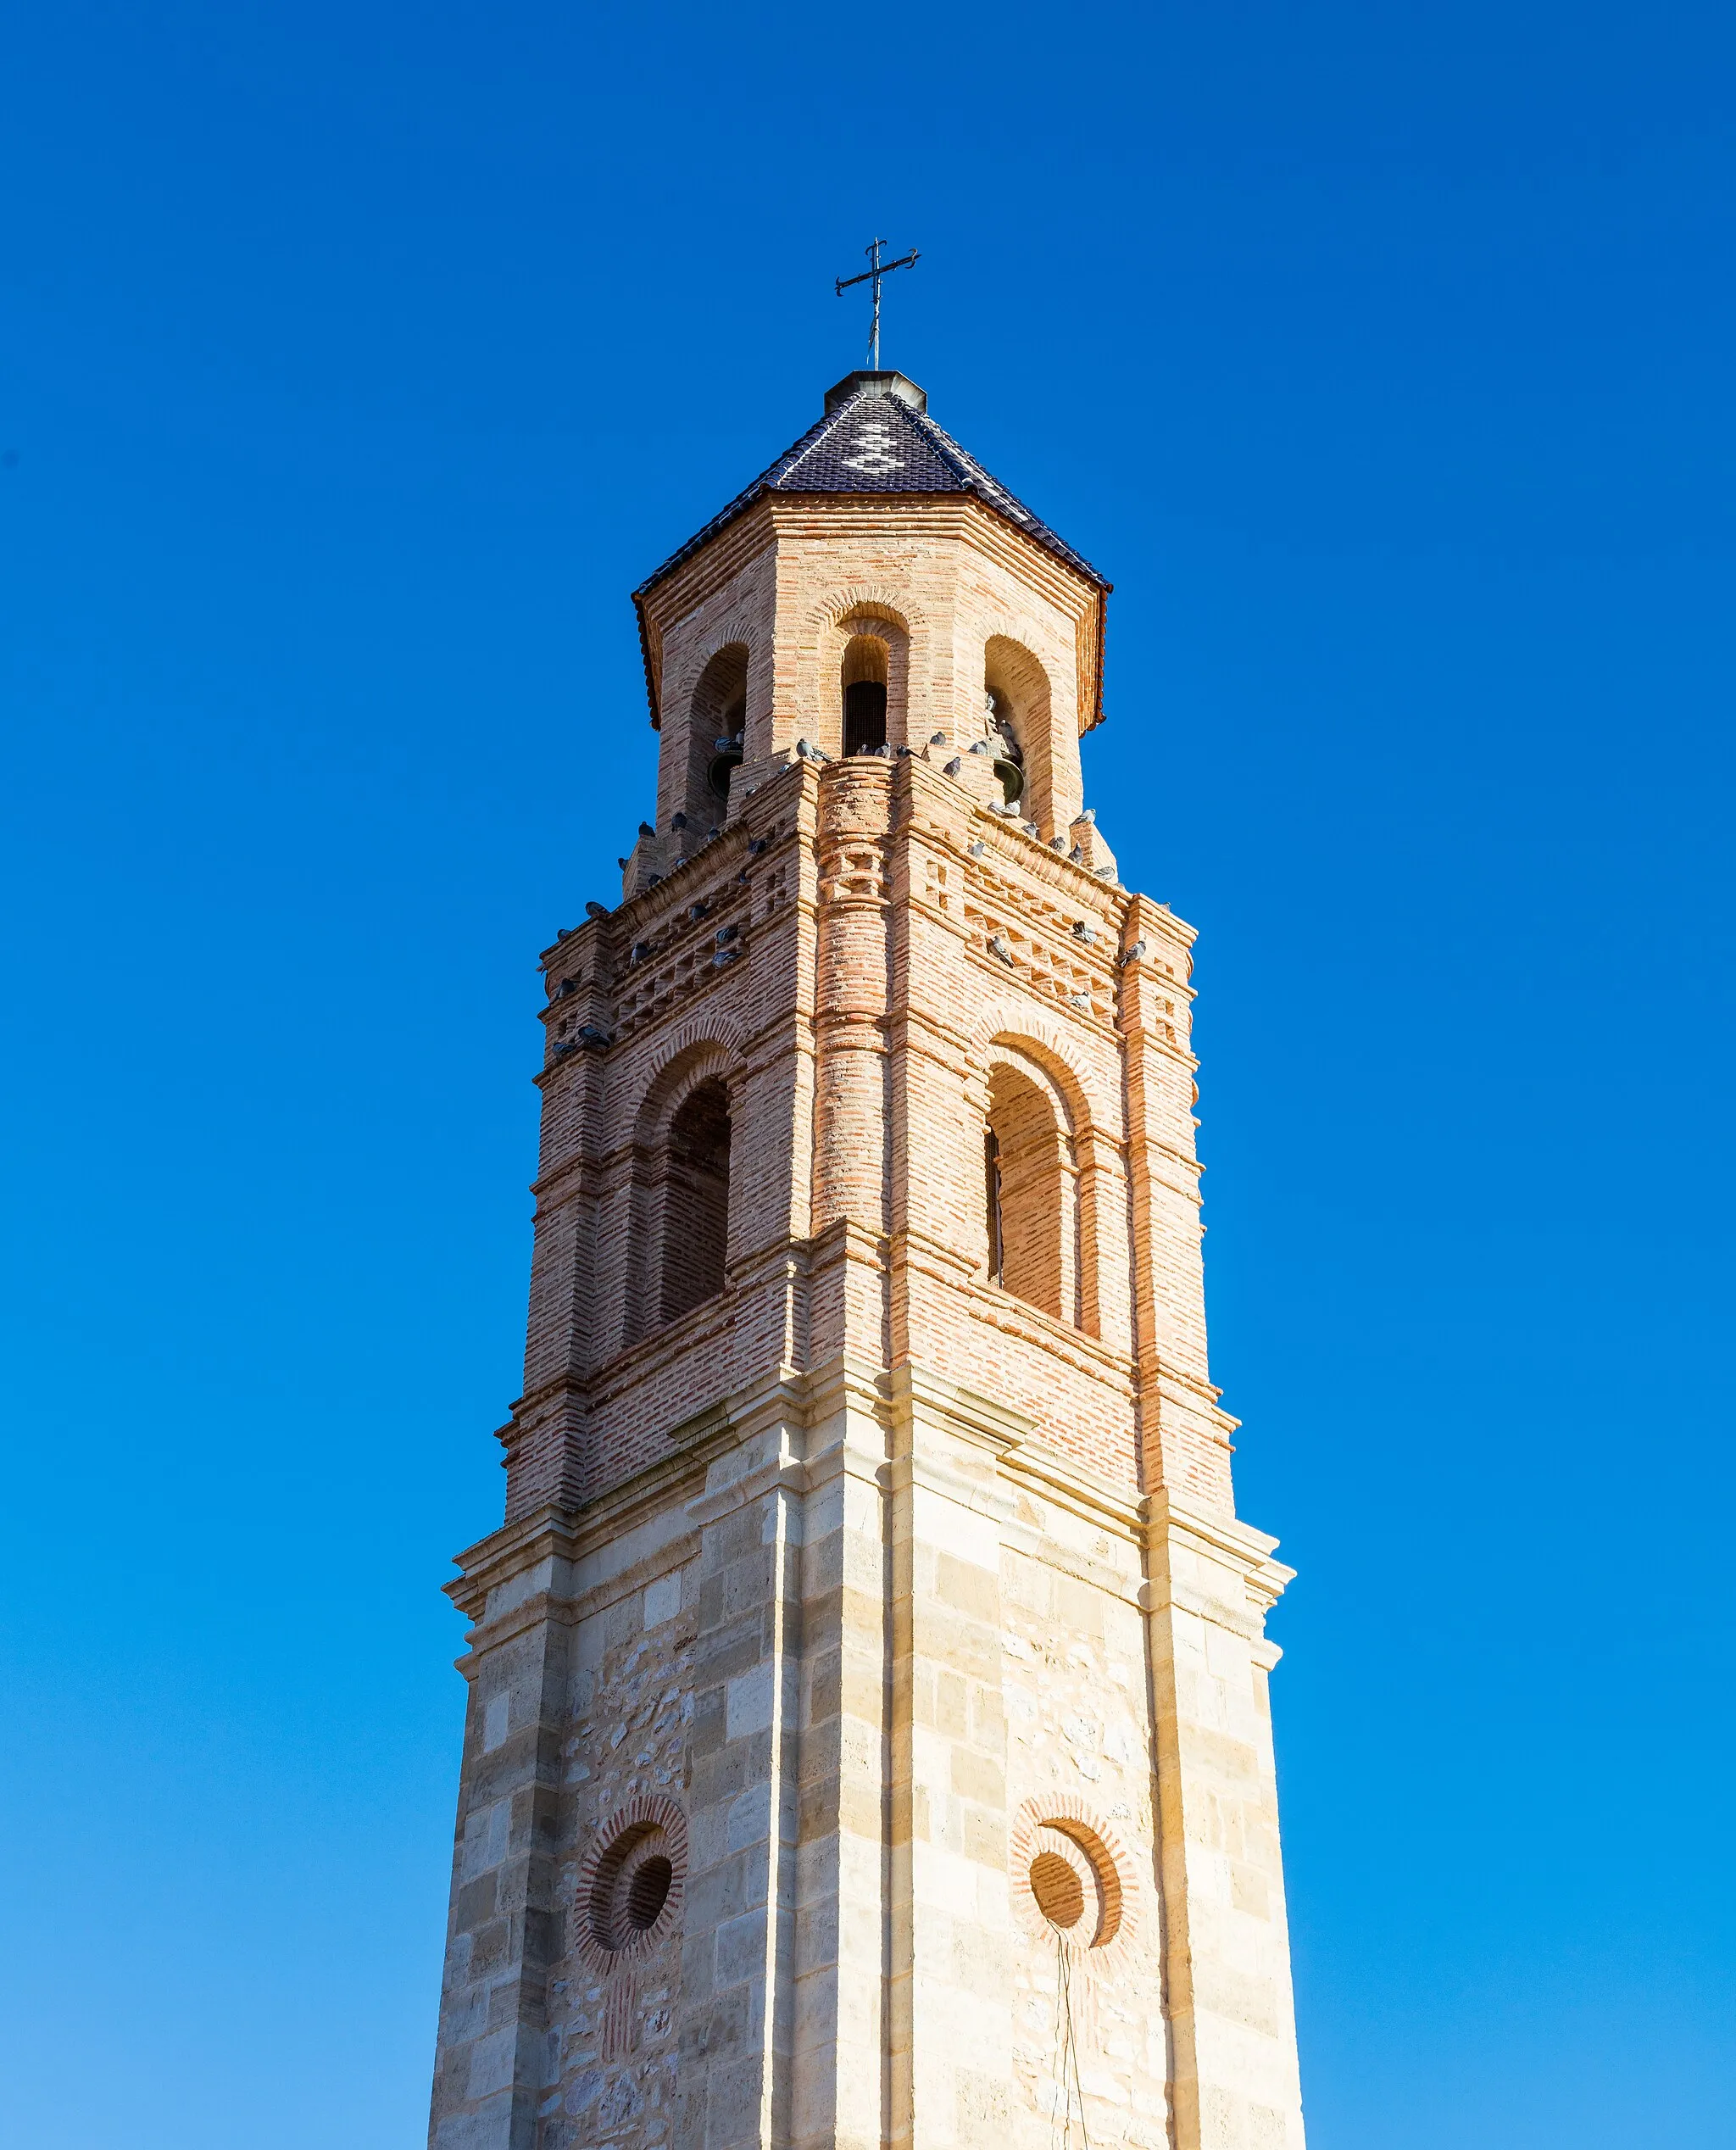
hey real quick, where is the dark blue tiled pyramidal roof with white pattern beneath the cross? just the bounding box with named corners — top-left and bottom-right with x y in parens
top-left (634, 372), bottom-right (1110, 602)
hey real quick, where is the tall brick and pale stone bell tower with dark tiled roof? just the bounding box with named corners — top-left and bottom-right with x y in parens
top-left (430, 372), bottom-right (1302, 2150)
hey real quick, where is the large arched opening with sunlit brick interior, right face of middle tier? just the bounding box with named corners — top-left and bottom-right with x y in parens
top-left (984, 1062), bottom-right (1078, 1323)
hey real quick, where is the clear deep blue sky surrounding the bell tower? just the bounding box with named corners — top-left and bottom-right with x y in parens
top-left (0, 0), bottom-right (1736, 2150)
